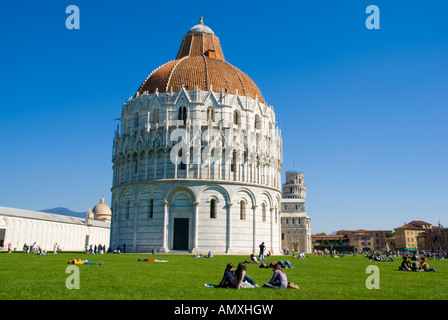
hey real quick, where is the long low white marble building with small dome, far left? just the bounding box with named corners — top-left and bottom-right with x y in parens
top-left (0, 201), bottom-right (110, 252)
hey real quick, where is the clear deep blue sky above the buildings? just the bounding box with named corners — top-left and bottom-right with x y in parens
top-left (0, 0), bottom-right (448, 233)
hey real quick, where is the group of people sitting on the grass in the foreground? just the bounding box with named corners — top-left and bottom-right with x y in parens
top-left (208, 262), bottom-right (299, 289)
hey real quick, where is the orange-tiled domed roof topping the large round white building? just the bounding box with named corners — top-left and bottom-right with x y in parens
top-left (136, 17), bottom-right (264, 103)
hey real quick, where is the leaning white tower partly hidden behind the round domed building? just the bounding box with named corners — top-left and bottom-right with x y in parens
top-left (281, 171), bottom-right (312, 253)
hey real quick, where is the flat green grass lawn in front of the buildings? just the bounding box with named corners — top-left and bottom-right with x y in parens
top-left (0, 253), bottom-right (448, 300)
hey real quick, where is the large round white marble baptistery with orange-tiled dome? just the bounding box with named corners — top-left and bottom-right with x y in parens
top-left (111, 18), bottom-right (283, 254)
